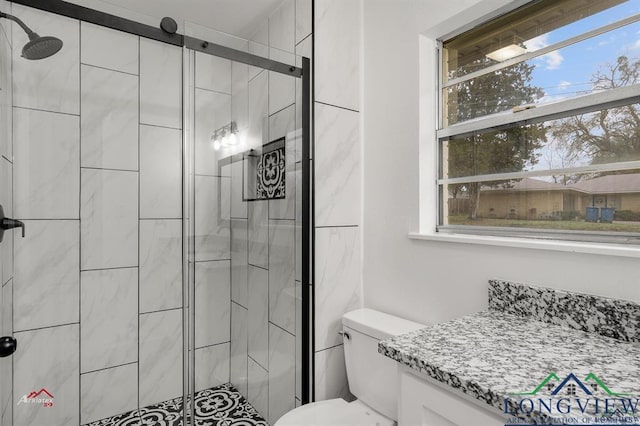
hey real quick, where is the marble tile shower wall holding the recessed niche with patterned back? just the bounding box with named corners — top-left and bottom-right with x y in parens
top-left (212, 0), bottom-right (312, 424)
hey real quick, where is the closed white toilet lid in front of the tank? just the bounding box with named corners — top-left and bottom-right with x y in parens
top-left (275, 398), bottom-right (395, 426)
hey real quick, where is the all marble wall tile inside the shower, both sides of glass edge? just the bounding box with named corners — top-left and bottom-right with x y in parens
top-left (0, 0), bottom-right (312, 425)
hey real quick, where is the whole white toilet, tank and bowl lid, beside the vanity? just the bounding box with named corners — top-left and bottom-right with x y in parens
top-left (274, 309), bottom-right (425, 426)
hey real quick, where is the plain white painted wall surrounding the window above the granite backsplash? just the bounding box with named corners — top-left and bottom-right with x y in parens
top-left (363, 0), bottom-right (640, 330)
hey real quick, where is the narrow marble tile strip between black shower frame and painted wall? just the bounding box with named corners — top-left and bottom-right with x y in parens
top-left (313, 0), bottom-right (362, 400)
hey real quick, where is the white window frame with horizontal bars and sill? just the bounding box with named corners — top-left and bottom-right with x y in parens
top-left (409, 0), bottom-right (640, 258)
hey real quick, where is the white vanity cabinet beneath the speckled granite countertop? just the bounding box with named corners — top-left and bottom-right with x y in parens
top-left (398, 366), bottom-right (506, 426)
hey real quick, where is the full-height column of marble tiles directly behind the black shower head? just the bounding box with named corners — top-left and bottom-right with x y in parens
top-left (2, 4), bottom-right (81, 425)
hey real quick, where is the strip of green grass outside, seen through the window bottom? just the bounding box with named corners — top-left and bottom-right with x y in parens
top-left (449, 215), bottom-right (640, 233)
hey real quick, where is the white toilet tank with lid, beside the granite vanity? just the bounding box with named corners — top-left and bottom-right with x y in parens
top-left (342, 309), bottom-right (425, 421)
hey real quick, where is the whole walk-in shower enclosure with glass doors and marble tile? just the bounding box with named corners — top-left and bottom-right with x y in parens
top-left (0, 0), bottom-right (313, 426)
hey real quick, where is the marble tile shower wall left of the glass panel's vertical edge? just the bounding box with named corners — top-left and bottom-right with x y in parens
top-left (0, 3), bottom-right (182, 426)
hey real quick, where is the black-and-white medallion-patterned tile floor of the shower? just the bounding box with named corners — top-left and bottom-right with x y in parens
top-left (86, 384), bottom-right (269, 426)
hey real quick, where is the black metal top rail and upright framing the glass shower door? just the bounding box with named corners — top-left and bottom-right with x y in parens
top-left (8, 0), bottom-right (315, 422)
